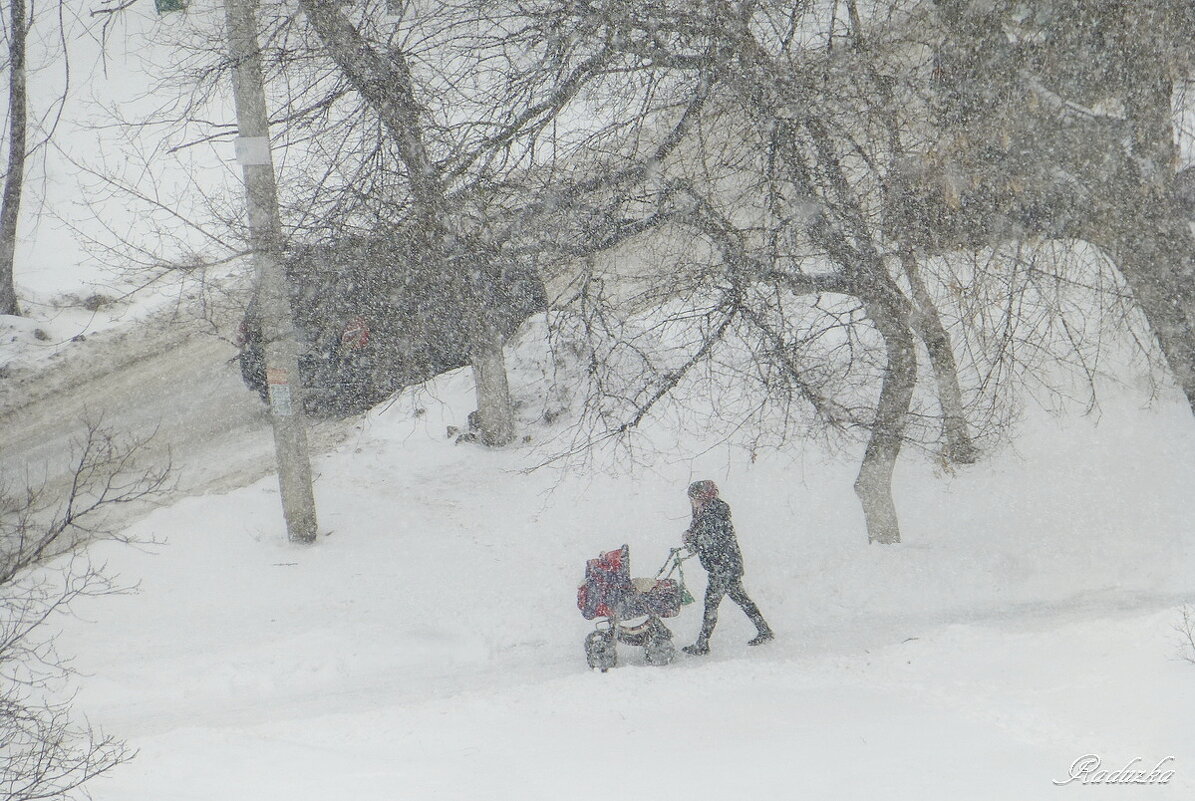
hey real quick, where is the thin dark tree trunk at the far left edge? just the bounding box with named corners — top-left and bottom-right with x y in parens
top-left (0, 0), bottom-right (29, 314)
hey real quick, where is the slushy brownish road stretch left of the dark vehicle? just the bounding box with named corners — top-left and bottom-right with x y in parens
top-left (0, 306), bottom-right (343, 521)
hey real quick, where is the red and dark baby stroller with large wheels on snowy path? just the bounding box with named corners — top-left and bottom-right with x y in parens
top-left (577, 545), bottom-right (693, 673)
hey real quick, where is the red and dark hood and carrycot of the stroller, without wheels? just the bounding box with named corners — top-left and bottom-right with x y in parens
top-left (577, 545), bottom-right (681, 620)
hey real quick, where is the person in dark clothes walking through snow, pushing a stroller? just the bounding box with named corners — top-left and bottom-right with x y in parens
top-left (681, 481), bottom-right (774, 656)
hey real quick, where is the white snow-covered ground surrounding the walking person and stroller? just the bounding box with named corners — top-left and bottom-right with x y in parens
top-left (28, 322), bottom-right (1195, 801)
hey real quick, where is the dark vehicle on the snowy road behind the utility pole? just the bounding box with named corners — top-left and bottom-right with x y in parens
top-left (239, 236), bottom-right (547, 417)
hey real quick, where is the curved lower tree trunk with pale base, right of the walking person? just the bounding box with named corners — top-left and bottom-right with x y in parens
top-left (854, 301), bottom-right (917, 545)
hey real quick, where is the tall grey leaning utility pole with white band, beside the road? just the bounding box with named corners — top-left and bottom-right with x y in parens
top-left (225, 0), bottom-right (317, 543)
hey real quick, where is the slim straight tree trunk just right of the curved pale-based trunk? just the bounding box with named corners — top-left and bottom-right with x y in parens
top-left (901, 250), bottom-right (979, 464)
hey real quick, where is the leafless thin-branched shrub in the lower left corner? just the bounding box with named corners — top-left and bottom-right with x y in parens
top-left (0, 424), bottom-right (168, 801)
